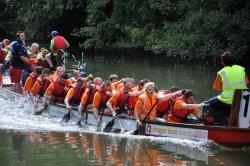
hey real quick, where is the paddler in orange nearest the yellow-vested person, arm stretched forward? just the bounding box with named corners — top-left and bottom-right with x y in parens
top-left (167, 90), bottom-right (204, 124)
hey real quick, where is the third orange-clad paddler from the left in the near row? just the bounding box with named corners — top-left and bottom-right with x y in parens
top-left (41, 73), bottom-right (70, 110)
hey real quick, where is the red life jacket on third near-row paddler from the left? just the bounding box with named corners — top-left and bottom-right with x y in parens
top-left (52, 80), bottom-right (66, 103)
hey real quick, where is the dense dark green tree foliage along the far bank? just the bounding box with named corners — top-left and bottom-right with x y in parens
top-left (0, 0), bottom-right (250, 57)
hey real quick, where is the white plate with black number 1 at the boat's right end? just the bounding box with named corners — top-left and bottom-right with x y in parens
top-left (238, 90), bottom-right (250, 128)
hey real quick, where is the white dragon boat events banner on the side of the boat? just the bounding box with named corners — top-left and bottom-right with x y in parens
top-left (146, 124), bottom-right (208, 140)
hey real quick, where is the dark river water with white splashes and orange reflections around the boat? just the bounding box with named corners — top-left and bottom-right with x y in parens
top-left (0, 53), bottom-right (250, 166)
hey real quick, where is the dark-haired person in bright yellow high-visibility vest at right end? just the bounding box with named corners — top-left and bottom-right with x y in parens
top-left (208, 51), bottom-right (249, 126)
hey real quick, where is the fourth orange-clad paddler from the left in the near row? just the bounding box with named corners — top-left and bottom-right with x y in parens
top-left (64, 77), bottom-right (87, 111)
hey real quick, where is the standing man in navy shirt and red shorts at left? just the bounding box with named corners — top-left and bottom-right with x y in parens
top-left (10, 31), bottom-right (29, 93)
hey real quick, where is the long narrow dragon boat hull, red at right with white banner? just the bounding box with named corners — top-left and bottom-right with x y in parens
top-left (0, 88), bottom-right (250, 148)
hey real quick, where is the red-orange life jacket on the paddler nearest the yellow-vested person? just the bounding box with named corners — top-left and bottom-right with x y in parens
top-left (169, 98), bottom-right (189, 123)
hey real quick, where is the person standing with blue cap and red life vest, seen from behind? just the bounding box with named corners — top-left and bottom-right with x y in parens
top-left (50, 31), bottom-right (69, 67)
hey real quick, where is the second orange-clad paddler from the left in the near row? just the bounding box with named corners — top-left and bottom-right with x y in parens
top-left (30, 68), bottom-right (51, 97)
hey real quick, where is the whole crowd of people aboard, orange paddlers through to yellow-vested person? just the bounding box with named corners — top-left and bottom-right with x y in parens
top-left (0, 31), bottom-right (249, 125)
